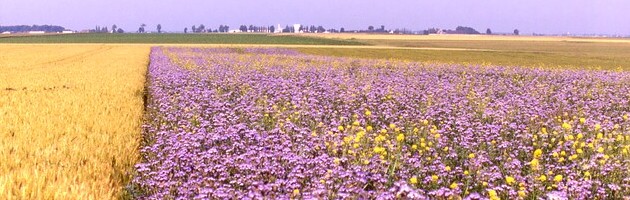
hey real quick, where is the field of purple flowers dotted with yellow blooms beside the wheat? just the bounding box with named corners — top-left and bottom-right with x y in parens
top-left (133, 47), bottom-right (630, 199)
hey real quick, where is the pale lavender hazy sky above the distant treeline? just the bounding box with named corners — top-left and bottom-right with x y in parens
top-left (0, 0), bottom-right (630, 35)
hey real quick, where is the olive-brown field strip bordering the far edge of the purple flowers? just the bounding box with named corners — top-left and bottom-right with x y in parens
top-left (298, 48), bottom-right (630, 70)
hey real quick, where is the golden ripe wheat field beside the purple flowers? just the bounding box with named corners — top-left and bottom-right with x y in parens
top-left (0, 45), bottom-right (149, 199)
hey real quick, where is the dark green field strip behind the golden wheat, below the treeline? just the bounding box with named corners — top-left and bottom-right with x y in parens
top-left (0, 33), bottom-right (364, 45)
